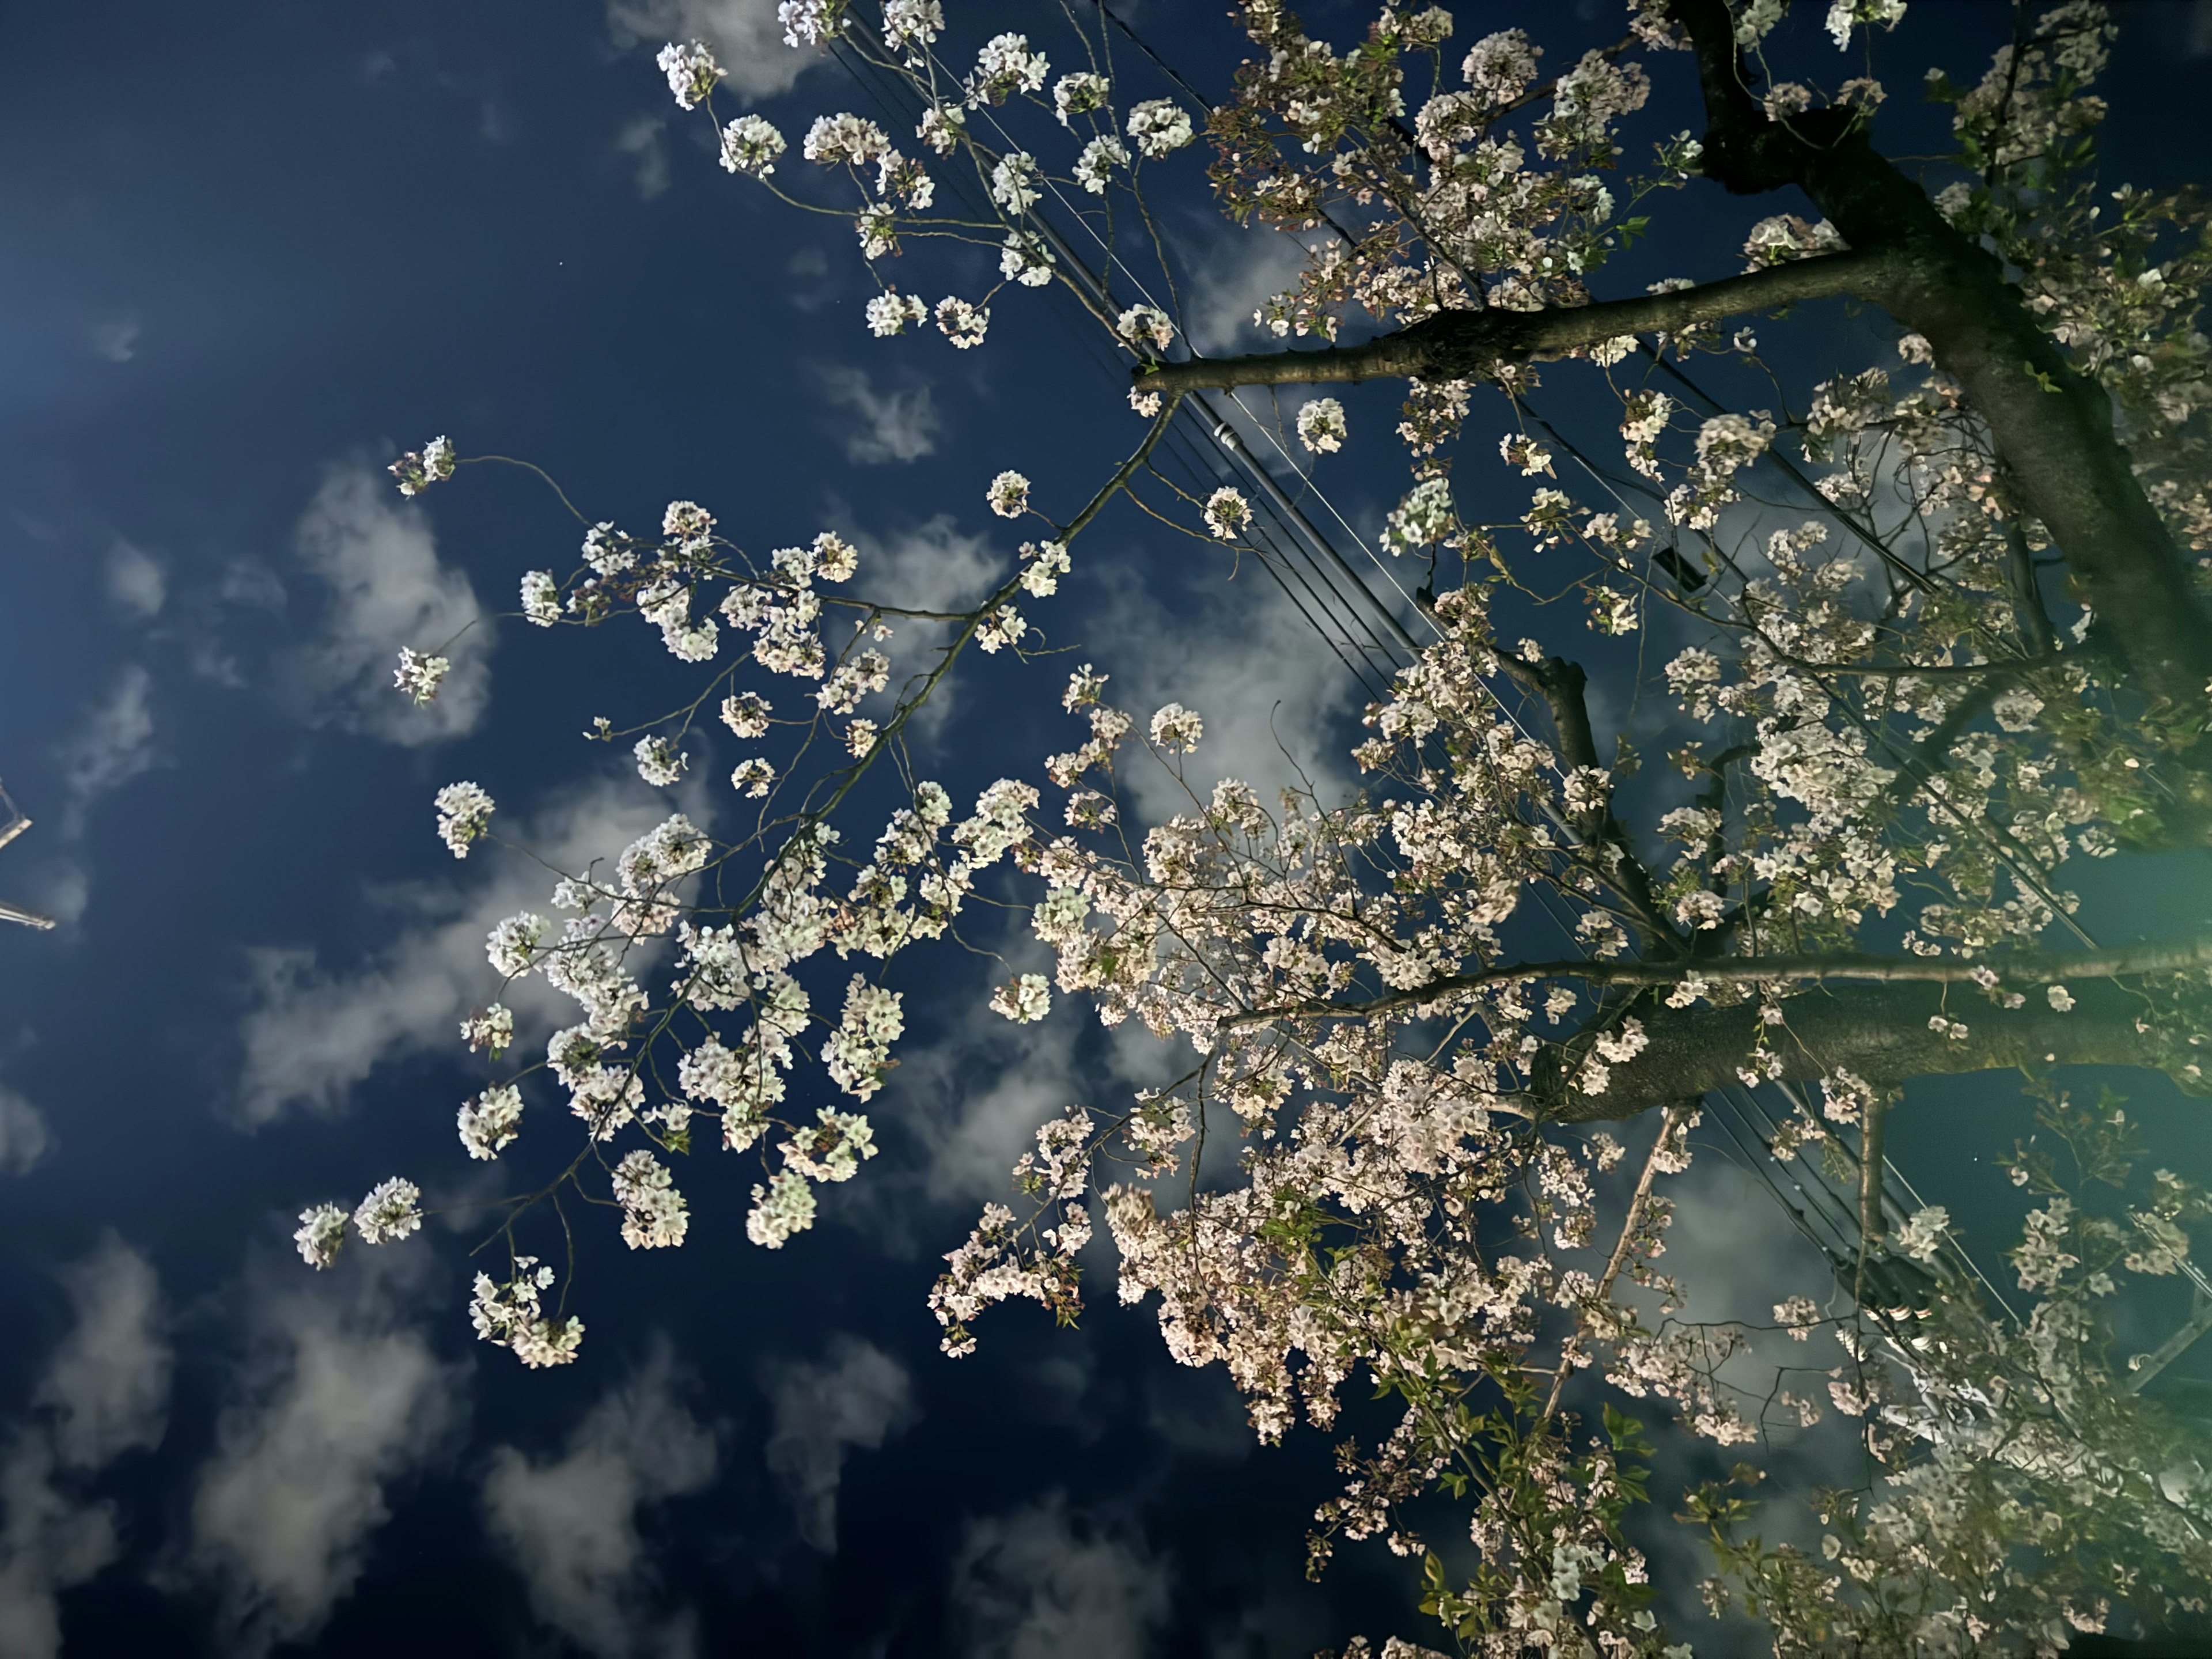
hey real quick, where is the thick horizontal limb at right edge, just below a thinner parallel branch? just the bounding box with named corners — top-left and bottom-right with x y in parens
top-left (1535, 984), bottom-right (2194, 1124)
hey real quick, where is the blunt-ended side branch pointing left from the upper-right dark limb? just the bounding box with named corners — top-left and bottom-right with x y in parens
top-left (1137, 250), bottom-right (1896, 394)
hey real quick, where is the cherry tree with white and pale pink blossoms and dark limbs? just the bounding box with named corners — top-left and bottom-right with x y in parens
top-left (320, 0), bottom-right (2212, 1654)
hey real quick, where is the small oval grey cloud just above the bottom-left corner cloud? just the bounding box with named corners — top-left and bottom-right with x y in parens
top-left (31, 1232), bottom-right (171, 1469)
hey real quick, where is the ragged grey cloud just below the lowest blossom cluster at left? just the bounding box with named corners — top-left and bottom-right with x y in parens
top-left (482, 1347), bottom-right (717, 1659)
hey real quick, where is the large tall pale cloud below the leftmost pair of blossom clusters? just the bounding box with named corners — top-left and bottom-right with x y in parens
top-left (184, 1245), bottom-right (467, 1654)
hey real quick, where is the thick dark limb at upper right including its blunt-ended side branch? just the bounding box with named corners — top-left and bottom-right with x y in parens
top-left (1168, 0), bottom-right (2212, 725)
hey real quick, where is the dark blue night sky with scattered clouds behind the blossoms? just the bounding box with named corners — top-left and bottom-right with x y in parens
top-left (13, 0), bottom-right (2212, 1659)
